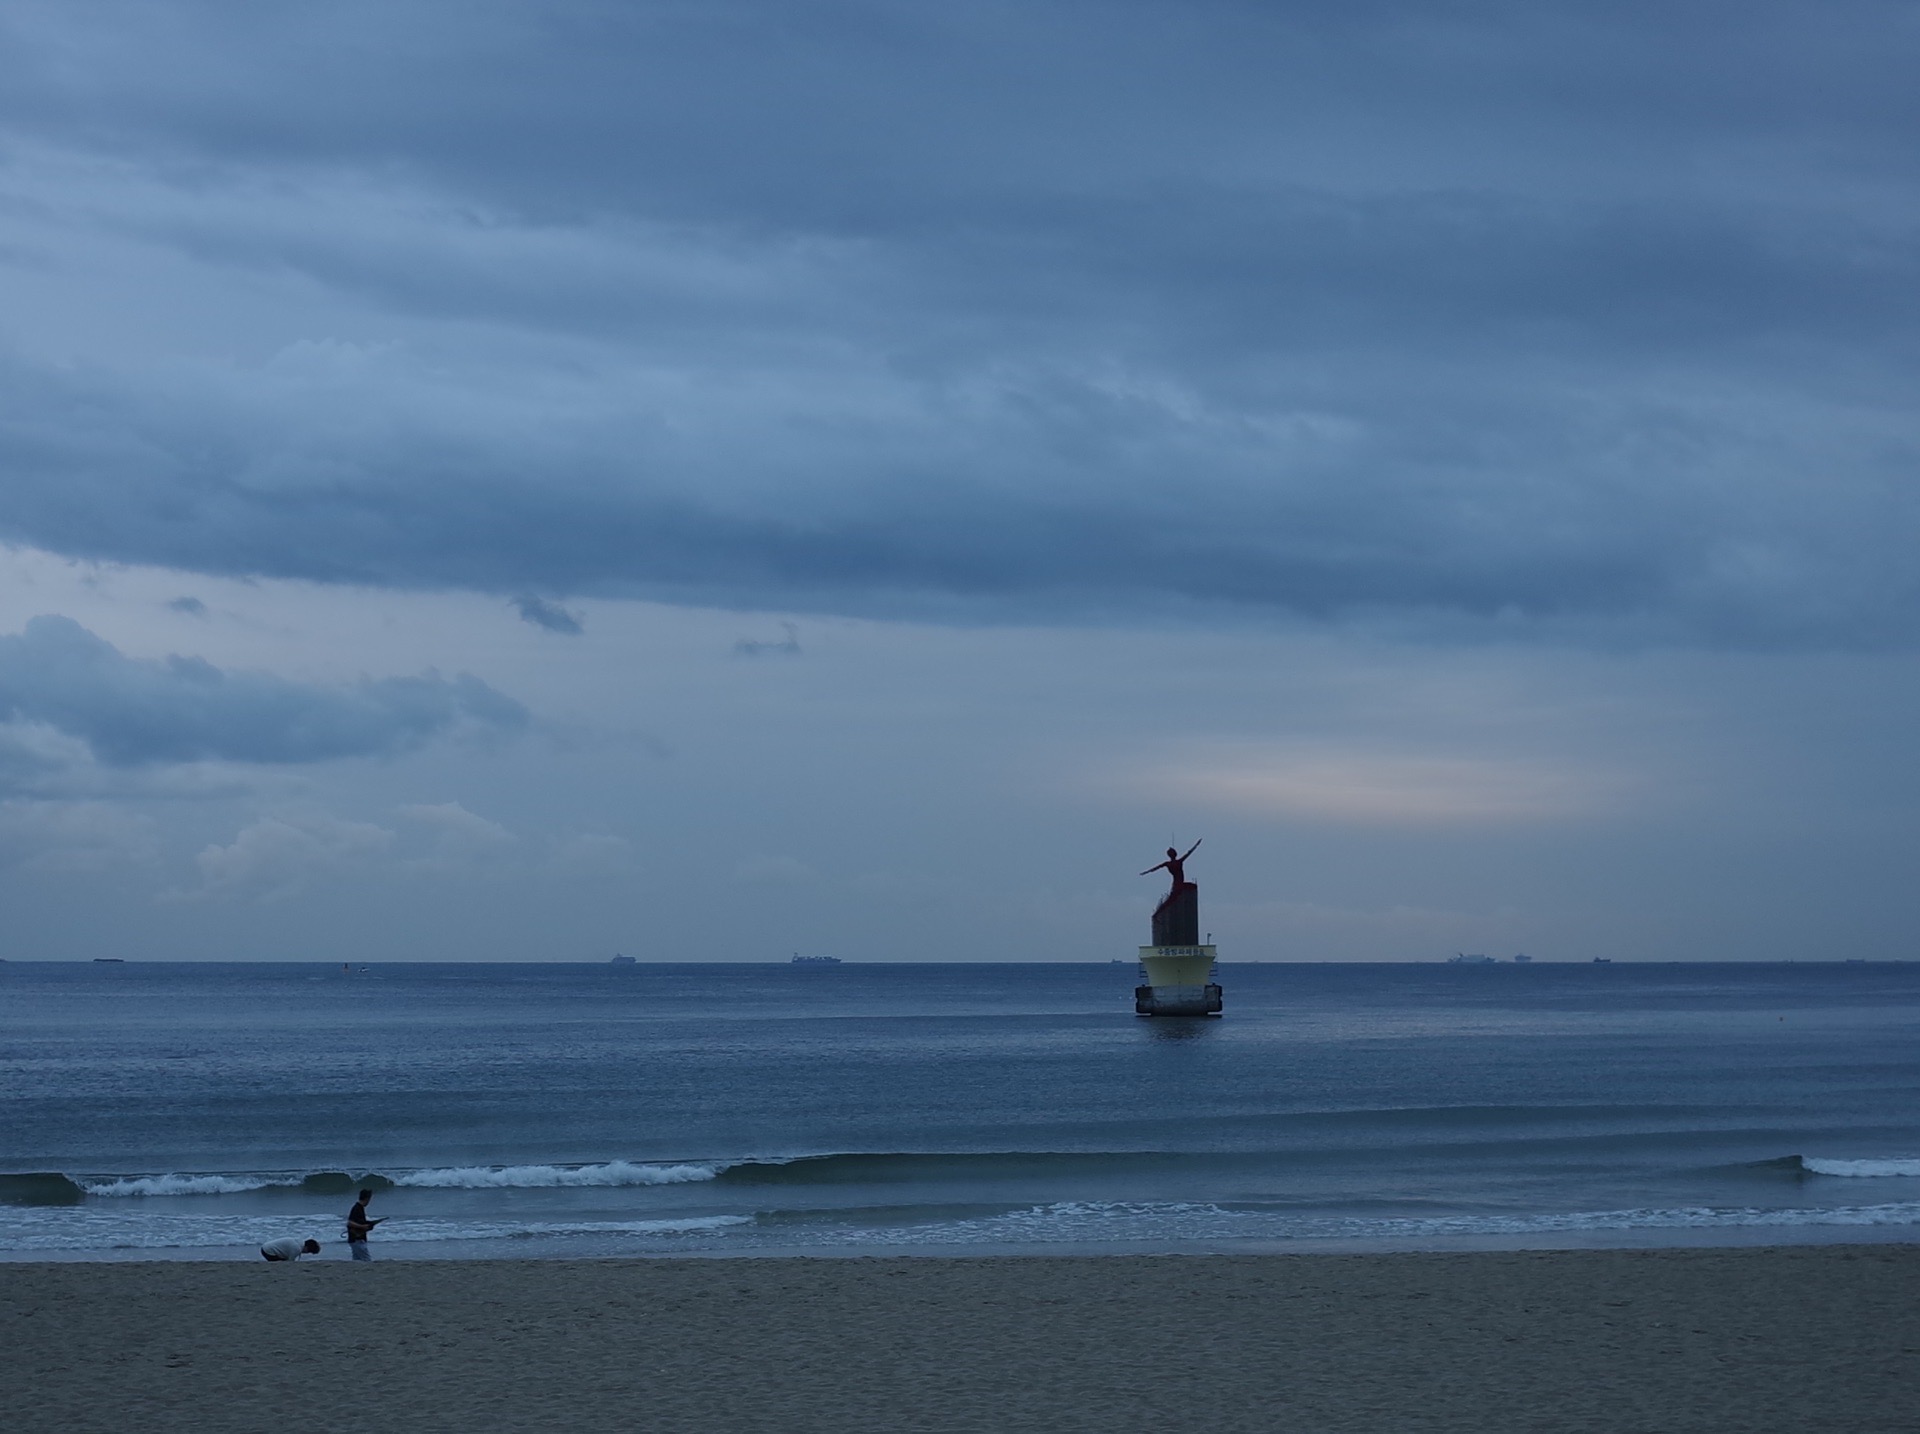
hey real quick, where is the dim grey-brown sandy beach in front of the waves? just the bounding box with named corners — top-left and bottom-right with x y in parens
top-left (0, 1246), bottom-right (1920, 1434)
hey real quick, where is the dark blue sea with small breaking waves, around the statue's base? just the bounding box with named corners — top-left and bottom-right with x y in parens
top-left (0, 962), bottom-right (1920, 1259)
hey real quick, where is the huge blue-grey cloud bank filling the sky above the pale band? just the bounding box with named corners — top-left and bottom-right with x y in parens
top-left (0, 2), bottom-right (1920, 643)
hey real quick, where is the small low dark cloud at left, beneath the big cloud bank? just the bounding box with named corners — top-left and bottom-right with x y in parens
top-left (0, 616), bottom-right (528, 766)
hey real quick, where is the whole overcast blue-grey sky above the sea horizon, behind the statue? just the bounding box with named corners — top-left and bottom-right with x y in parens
top-left (0, 0), bottom-right (1920, 960)
